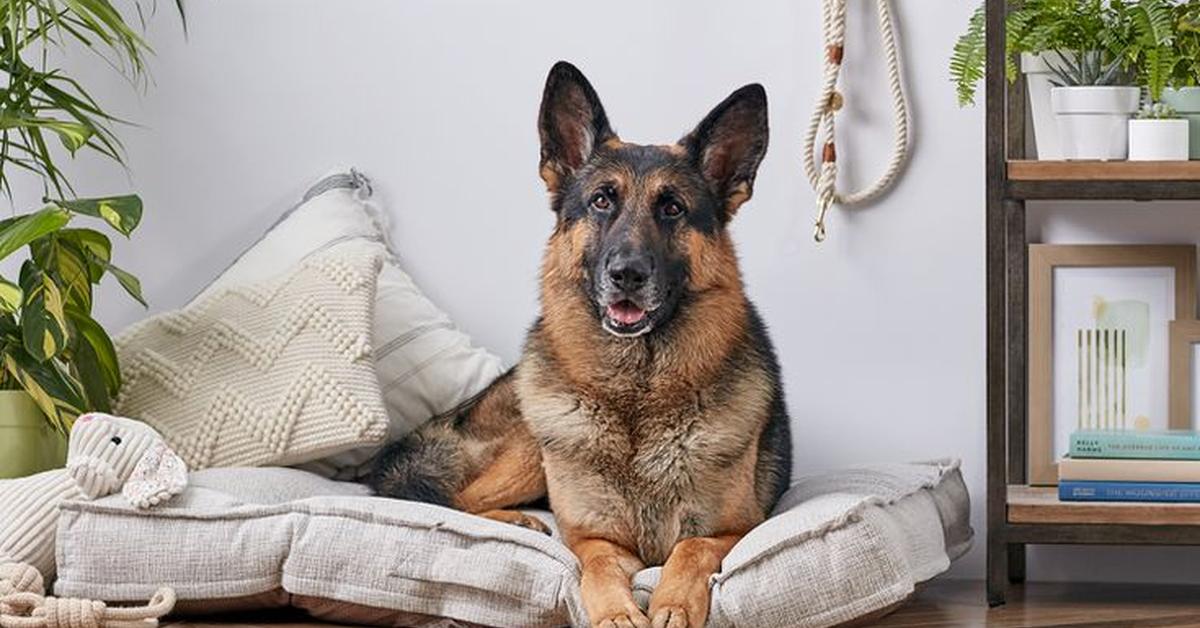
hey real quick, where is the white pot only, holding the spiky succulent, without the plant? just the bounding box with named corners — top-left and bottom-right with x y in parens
top-left (1050, 85), bottom-right (1141, 161)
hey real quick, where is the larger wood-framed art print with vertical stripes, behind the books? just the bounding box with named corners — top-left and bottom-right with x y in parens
top-left (1028, 244), bottom-right (1196, 485)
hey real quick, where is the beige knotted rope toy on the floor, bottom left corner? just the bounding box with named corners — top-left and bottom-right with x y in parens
top-left (0, 563), bottom-right (175, 628)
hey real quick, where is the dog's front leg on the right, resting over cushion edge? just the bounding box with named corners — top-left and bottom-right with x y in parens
top-left (650, 534), bottom-right (742, 628)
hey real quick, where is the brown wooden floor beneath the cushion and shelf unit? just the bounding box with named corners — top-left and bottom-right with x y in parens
top-left (167, 580), bottom-right (1200, 628)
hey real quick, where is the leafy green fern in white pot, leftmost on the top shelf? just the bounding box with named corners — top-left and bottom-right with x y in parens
top-left (950, 0), bottom-right (1112, 160)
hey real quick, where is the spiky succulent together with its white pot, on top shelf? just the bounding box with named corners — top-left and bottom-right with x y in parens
top-left (1048, 50), bottom-right (1141, 161)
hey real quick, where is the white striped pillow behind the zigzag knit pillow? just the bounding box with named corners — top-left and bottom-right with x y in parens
top-left (188, 171), bottom-right (504, 479)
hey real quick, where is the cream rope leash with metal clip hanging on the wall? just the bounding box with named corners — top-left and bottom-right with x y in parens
top-left (804, 0), bottom-right (908, 243)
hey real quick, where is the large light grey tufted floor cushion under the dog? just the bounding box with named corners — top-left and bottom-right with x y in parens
top-left (55, 461), bottom-right (972, 627)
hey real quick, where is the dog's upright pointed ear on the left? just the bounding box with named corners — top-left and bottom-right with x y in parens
top-left (538, 61), bottom-right (617, 192)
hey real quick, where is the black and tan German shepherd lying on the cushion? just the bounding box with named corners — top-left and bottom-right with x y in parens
top-left (368, 62), bottom-right (792, 628)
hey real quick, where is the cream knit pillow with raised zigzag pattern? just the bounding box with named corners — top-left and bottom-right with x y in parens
top-left (115, 245), bottom-right (388, 469)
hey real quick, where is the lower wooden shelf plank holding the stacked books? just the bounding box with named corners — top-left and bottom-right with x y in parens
top-left (1008, 485), bottom-right (1200, 526)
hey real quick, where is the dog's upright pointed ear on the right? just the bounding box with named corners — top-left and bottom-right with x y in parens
top-left (679, 83), bottom-right (769, 220)
